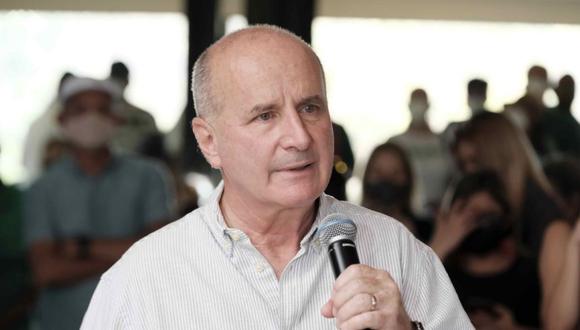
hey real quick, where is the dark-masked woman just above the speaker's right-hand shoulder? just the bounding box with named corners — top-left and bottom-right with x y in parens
top-left (362, 142), bottom-right (431, 242)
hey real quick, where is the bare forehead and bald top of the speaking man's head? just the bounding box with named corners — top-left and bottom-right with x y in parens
top-left (199, 28), bottom-right (326, 122)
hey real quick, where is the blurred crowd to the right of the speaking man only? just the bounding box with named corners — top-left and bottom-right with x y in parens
top-left (362, 66), bottom-right (580, 329)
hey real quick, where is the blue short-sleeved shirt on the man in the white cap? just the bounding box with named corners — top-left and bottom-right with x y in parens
top-left (24, 156), bottom-right (172, 329)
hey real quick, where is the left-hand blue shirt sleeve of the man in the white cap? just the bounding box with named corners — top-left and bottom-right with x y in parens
top-left (23, 181), bottom-right (55, 246)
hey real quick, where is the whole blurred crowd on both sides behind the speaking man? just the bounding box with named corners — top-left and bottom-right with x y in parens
top-left (0, 62), bottom-right (580, 329)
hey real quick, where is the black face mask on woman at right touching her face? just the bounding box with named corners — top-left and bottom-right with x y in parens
top-left (459, 213), bottom-right (511, 256)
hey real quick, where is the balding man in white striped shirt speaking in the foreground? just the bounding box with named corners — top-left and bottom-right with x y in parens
top-left (83, 26), bottom-right (471, 329)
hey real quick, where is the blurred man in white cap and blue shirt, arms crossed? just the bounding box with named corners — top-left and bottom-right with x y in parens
top-left (24, 77), bottom-right (172, 329)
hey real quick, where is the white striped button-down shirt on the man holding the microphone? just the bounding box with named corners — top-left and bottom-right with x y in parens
top-left (81, 184), bottom-right (473, 330)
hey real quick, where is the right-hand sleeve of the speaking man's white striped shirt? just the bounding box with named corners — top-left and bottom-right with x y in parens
top-left (401, 233), bottom-right (474, 330)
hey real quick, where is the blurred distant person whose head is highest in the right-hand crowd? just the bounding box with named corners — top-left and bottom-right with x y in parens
top-left (505, 65), bottom-right (549, 157)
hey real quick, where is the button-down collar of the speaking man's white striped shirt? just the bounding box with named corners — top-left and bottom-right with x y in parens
top-left (204, 181), bottom-right (332, 256)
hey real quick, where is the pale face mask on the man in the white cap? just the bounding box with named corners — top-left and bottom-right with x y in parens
top-left (62, 111), bottom-right (117, 149)
